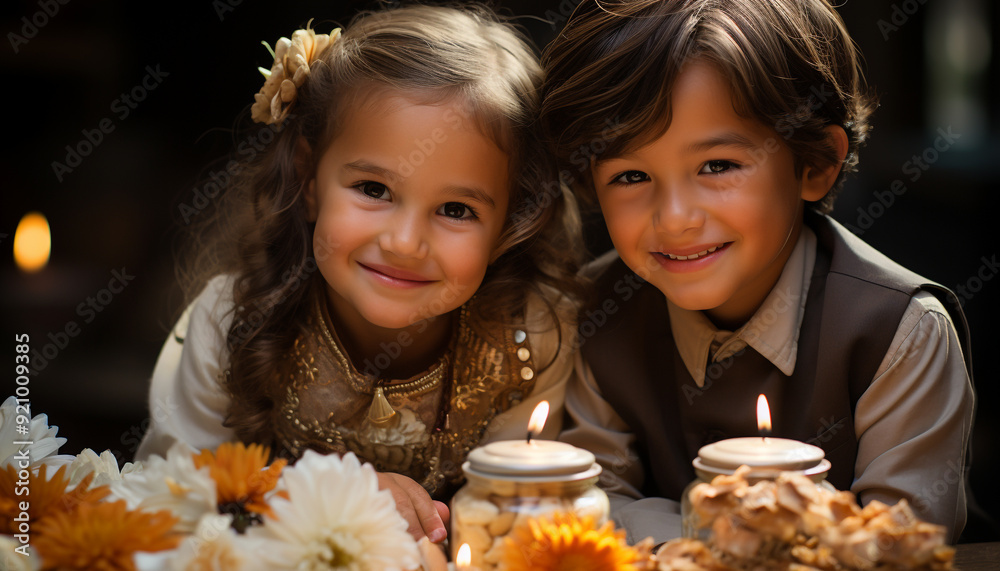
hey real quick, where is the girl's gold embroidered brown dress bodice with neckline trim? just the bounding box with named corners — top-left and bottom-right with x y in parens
top-left (272, 295), bottom-right (535, 495)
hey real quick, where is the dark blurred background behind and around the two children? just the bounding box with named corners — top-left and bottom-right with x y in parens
top-left (0, 0), bottom-right (1000, 537)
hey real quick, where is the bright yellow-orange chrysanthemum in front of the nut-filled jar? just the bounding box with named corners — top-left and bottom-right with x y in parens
top-left (500, 512), bottom-right (650, 571)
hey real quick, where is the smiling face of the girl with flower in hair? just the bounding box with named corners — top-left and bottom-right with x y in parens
top-left (306, 90), bottom-right (509, 329)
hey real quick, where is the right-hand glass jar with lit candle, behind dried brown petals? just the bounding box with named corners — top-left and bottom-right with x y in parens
top-left (681, 437), bottom-right (834, 541)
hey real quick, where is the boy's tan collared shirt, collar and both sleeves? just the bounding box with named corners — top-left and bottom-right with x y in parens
top-left (560, 227), bottom-right (974, 542)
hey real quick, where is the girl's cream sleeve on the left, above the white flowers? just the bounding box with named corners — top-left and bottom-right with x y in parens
top-left (135, 276), bottom-right (236, 461)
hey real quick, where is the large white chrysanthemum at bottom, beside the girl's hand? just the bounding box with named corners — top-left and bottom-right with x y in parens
top-left (245, 450), bottom-right (420, 571)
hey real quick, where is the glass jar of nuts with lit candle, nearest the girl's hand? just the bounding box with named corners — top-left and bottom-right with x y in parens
top-left (450, 441), bottom-right (610, 571)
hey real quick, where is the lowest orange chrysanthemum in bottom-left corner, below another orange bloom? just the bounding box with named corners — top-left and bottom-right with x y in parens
top-left (31, 500), bottom-right (181, 571)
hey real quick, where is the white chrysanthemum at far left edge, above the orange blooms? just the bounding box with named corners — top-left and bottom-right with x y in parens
top-left (0, 397), bottom-right (73, 474)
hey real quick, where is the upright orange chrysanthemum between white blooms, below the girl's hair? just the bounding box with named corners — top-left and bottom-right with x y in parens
top-left (194, 442), bottom-right (288, 531)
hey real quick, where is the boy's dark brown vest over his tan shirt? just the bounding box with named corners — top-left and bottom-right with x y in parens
top-left (581, 213), bottom-right (972, 499)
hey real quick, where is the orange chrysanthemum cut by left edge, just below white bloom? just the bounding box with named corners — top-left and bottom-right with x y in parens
top-left (0, 464), bottom-right (110, 535)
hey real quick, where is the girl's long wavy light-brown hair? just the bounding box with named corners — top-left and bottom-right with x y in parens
top-left (181, 5), bottom-right (582, 443)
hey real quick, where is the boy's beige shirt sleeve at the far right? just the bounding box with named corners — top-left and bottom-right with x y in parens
top-left (851, 293), bottom-right (974, 542)
